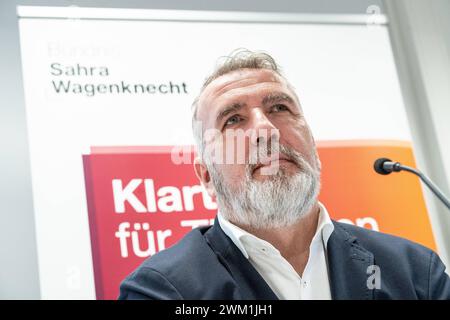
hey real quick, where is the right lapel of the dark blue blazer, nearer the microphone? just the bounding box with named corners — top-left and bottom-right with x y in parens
top-left (327, 221), bottom-right (375, 300)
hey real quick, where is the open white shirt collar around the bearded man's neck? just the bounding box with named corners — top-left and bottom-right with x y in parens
top-left (217, 202), bottom-right (334, 259)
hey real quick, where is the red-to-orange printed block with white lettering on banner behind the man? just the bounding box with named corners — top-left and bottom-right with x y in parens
top-left (83, 141), bottom-right (435, 299)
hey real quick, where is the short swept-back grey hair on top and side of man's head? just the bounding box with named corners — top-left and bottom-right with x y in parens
top-left (192, 48), bottom-right (284, 156)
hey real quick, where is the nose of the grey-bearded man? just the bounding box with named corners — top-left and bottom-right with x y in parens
top-left (250, 108), bottom-right (280, 146)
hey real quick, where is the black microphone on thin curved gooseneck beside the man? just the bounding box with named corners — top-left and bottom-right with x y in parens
top-left (373, 158), bottom-right (450, 210)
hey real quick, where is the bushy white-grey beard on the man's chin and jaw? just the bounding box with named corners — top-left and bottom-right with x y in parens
top-left (209, 145), bottom-right (320, 229)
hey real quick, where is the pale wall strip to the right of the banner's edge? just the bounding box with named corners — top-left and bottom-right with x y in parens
top-left (385, 0), bottom-right (450, 271)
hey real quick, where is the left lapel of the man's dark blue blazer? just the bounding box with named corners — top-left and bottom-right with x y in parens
top-left (205, 217), bottom-right (278, 300)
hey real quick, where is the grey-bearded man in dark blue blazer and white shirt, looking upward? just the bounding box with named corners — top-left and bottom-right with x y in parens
top-left (119, 50), bottom-right (450, 300)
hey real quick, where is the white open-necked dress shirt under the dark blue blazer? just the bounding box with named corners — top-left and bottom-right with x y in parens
top-left (218, 202), bottom-right (334, 300)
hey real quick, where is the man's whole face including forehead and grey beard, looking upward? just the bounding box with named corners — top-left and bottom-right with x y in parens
top-left (195, 69), bottom-right (320, 228)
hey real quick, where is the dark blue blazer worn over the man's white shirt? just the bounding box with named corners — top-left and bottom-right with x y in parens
top-left (119, 218), bottom-right (450, 300)
